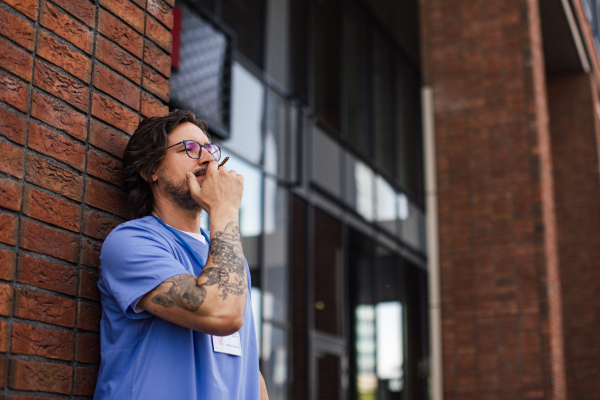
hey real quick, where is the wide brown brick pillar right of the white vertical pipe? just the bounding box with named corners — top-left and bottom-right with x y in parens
top-left (420, 0), bottom-right (565, 400)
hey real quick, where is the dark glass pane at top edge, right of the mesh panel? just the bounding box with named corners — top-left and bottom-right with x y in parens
top-left (221, 0), bottom-right (265, 69)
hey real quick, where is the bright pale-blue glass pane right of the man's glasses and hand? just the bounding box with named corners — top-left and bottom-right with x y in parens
top-left (223, 63), bottom-right (265, 164)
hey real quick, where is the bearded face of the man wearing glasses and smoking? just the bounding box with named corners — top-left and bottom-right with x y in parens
top-left (152, 122), bottom-right (213, 211)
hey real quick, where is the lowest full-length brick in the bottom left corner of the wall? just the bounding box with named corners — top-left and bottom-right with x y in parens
top-left (8, 359), bottom-right (73, 394)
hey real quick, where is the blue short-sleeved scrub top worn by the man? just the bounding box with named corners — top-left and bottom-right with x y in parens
top-left (94, 217), bottom-right (260, 400)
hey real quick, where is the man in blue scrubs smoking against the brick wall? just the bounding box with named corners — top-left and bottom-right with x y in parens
top-left (94, 110), bottom-right (267, 400)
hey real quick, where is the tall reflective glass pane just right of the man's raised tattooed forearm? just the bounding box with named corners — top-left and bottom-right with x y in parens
top-left (262, 178), bottom-right (289, 322)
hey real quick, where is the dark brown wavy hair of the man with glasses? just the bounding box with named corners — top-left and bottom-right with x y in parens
top-left (123, 110), bottom-right (210, 218)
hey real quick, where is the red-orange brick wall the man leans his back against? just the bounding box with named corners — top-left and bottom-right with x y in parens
top-left (0, 0), bottom-right (174, 400)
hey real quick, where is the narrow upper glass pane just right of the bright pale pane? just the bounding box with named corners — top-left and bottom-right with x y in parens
top-left (264, 90), bottom-right (289, 178)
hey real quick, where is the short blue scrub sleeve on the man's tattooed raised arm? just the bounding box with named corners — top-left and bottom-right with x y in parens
top-left (100, 224), bottom-right (190, 318)
